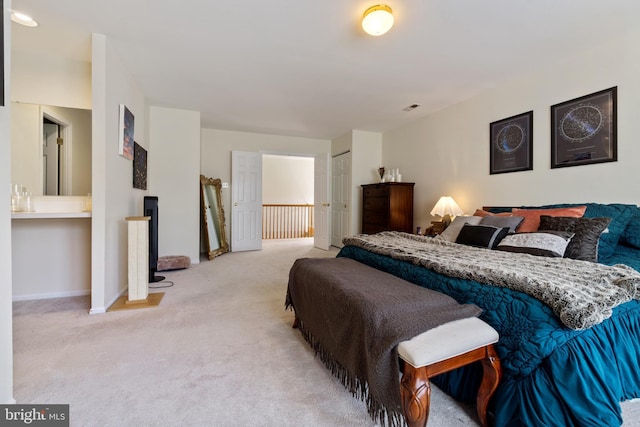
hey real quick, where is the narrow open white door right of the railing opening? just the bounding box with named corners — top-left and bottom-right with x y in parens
top-left (313, 154), bottom-right (331, 251)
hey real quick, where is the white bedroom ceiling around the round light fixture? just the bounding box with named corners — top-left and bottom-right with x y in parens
top-left (12, 0), bottom-right (640, 139)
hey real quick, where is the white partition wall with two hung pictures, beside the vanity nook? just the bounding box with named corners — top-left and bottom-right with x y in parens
top-left (91, 34), bottom-right (148, 313)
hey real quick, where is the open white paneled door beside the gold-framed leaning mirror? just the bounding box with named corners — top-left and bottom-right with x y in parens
top-left (231, 151), bottom-right (262, 252)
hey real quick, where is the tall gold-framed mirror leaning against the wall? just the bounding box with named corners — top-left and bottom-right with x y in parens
top-left (200, 175), bottom-right (229, 259)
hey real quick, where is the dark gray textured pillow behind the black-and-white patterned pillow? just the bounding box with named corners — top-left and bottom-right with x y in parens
top-left (538, 215), bottom-right (611, 262)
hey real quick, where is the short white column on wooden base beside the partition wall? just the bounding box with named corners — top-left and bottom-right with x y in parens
top-left (125, 216), bottom-right (151, 304)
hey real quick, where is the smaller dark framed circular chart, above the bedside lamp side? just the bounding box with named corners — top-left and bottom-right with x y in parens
top-left (489, 111), bottom-right (533, 175)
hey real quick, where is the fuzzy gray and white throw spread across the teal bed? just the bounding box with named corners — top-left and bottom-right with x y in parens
top-left (343, 231), bottom-right (640, 329)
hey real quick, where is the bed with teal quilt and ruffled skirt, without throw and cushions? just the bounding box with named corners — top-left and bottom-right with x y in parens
top-left (338, 203), bottom-right (640, 427)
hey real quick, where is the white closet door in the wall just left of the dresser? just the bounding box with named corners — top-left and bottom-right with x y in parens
top-left (331, 152), bottom-right (351, 248)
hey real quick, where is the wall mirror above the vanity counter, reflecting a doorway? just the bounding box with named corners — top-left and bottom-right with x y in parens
top-left (11, 102), bottom-right (91, 196)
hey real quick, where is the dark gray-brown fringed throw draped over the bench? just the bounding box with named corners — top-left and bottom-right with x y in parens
top-left (285, 258), bottom-right (481, 426)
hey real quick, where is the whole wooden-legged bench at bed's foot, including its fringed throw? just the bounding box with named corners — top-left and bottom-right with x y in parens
top-left (285, 258), bottom-right (501, 427)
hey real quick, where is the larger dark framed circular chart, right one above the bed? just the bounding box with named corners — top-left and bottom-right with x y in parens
top-left (551, 86), bottom-right (618, 169)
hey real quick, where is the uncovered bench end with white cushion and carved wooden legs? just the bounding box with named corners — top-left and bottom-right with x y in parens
top-left (398, 317), bottom-right (501, 427)
